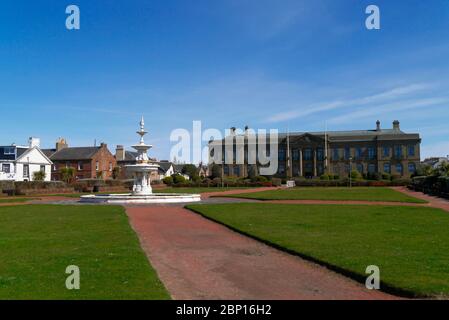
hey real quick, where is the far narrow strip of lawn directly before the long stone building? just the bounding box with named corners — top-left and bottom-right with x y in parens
top-left (219, 187), bottom-right (426, 203)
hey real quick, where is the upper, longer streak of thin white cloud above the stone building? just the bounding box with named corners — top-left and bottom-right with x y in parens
top-left (265, 83), bottom-right (431, 123)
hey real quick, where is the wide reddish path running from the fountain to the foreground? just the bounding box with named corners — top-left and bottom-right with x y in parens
top-left (126, 206), bottom-right (397, 300)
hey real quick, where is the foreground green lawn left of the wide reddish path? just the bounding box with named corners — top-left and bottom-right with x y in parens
top-left (0, 205), bottom-right (169, 299)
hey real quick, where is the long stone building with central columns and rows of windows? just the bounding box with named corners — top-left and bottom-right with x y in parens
top-left (209, 120), bottom-right (421, 178)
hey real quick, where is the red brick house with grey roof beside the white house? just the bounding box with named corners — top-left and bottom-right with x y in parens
top-left (45, 143), bottom-right (117, 180)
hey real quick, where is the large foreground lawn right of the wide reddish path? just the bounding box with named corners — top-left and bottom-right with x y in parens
top-left (187, 203), bottom-right (449, 298)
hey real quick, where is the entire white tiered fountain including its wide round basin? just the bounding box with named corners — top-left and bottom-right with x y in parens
top-left (81, 117), bottom-right (201, 203)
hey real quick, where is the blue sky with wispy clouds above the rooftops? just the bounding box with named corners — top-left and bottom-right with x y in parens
top-left (0, 0), bottom-right (449, 159)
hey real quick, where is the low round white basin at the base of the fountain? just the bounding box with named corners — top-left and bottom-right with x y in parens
top-left (80, 193), bottom-right (201, 204)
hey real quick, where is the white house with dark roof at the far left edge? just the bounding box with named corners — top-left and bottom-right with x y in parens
top-left (0, 138), bottom-right (53, 181)
